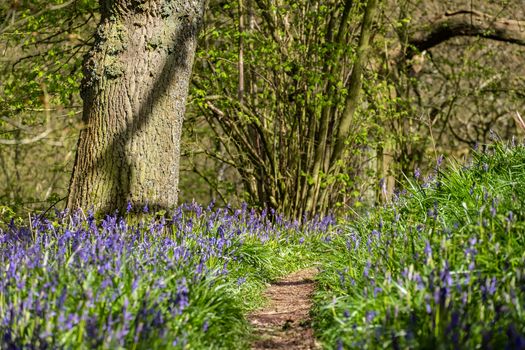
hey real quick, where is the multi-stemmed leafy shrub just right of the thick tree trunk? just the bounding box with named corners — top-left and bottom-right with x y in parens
top-left (190, 0), bottom-right (374, 217)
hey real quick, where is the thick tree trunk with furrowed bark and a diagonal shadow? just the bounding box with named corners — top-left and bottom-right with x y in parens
top-left (67, 0), bottom-right (205, 212)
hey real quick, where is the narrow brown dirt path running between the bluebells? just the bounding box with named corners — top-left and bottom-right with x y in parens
top-left (248, 268), bottom-right (320, 350)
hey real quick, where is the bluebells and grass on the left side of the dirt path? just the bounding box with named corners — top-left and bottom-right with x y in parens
top-left (0, 204), bottom-right (332, 349)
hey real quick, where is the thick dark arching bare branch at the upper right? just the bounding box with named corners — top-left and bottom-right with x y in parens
top-left (407, 10), bottom-right (525, 58)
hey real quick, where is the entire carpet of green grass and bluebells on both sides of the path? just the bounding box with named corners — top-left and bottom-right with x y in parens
top-left (8, 145), bottom-right (525, 349)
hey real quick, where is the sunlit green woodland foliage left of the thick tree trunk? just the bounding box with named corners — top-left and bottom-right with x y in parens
top-left (0, 0), bottom-right (97, 213)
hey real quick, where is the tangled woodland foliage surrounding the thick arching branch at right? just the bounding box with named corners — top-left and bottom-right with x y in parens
top-left (376, 0), bottom-right (525, 180)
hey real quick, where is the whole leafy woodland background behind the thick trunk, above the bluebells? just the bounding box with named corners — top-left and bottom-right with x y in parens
top-left (0, 0), bottom-right (525, 216)
